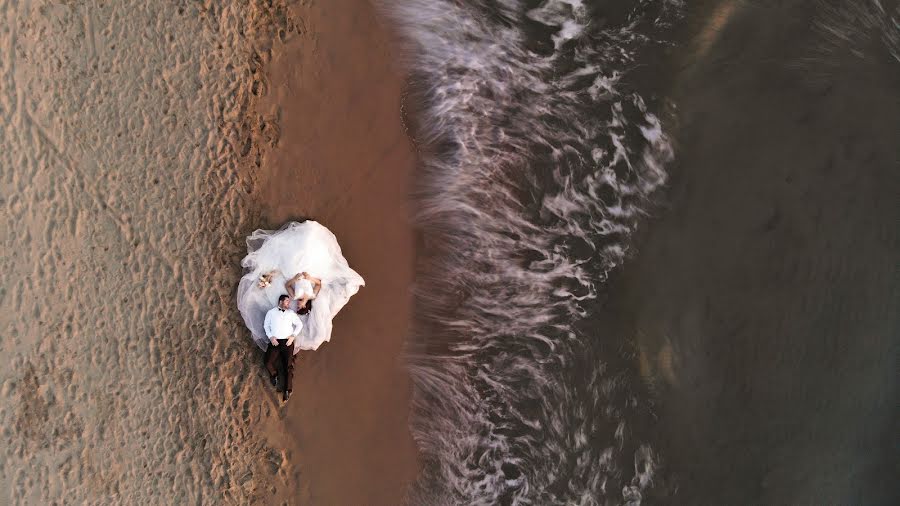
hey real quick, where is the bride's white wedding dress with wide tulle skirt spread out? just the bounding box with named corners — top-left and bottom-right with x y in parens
top-left (237, 220), bottom-right (365, 353)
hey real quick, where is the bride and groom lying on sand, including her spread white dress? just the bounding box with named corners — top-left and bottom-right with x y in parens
top-left (237, 221), bottom-right (365, 400)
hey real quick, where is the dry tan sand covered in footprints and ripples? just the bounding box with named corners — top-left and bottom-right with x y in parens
top-left (0, 0), bottom-right (297, 504)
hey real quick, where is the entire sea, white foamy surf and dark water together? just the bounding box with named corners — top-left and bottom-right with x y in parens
top-left (391, 0), bottom-right (900, 504)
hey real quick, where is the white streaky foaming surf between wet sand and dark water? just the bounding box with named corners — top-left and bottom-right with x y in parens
top-left (387, 0), bottom-right (681, 504)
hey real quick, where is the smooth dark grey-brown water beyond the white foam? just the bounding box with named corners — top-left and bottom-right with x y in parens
top-left (616, 2), bottom-right (900, 504)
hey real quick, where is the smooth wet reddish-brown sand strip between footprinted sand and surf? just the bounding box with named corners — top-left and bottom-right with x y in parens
top-left (256, 0), bottom-right (417, 505)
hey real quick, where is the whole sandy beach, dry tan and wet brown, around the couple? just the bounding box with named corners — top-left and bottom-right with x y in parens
top-left (0, 0), bottom-right (415, 504)
